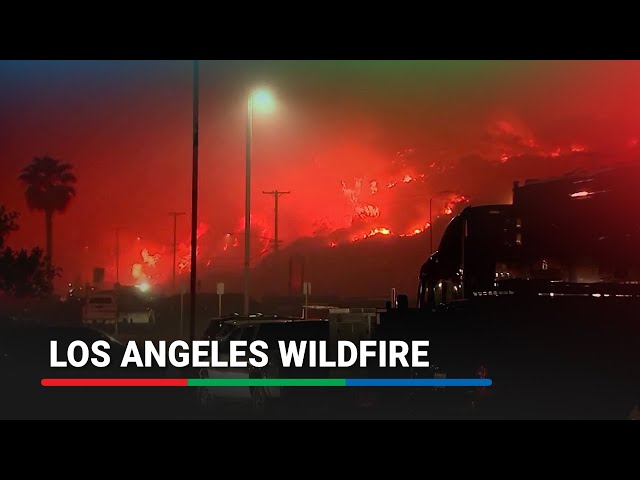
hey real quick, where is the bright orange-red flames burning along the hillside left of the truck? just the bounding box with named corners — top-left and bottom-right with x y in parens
top-left (125, 149), bottom-right (476, 284)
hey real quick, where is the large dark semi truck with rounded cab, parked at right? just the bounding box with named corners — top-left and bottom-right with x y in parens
top-left (418, 163), bottom-right (640, 309)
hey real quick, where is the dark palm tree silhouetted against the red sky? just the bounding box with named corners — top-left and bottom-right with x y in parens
top-left (18, 155), bottom-right (76, 263)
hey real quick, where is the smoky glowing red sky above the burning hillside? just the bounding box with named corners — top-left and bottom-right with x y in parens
top-left (0, 61), bottom-right (640, 292)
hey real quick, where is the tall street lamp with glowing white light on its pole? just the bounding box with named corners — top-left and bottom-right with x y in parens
top-left (244, 89), bottom-right (275, 316)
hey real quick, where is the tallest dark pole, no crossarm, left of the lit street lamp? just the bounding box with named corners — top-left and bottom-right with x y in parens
top-left (189, 60), bottom-right (200, 341)
